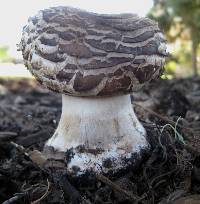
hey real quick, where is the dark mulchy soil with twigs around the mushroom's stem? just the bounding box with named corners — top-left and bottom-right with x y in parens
top-left (0, 78), bottom-right (200, 204)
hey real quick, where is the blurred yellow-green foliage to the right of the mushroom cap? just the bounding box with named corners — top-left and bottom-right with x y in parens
top-left (149, 0), bottom-right (200, 75)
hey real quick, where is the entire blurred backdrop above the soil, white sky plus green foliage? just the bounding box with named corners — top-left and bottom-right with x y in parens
top-left (0, 0), bottom-right (200, 79)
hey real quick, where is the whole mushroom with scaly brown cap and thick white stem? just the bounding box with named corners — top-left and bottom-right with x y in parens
top-left (20, 7), bottom-right (167, 174)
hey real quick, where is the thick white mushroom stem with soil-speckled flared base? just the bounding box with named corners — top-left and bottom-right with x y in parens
top-left (46, 95), bottom-right (149, 174)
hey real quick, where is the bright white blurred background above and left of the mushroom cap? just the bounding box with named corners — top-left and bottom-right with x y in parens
top-left (0, 0), bottom-right (153, 77)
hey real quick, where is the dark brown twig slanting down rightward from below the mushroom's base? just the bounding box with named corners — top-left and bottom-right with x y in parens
top-left (97, 174), bottom-right (141, 203)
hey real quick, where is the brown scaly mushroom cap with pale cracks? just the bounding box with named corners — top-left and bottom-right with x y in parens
top-left (19, 7), bottom-right (167, 96)
